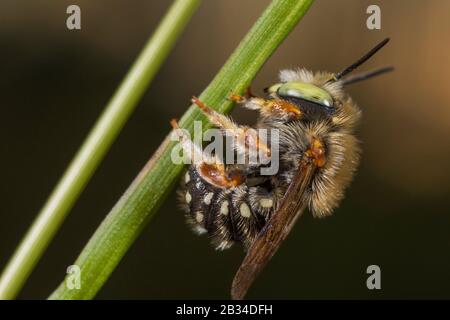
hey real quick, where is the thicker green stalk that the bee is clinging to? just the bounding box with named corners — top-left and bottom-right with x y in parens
top-left (50, 0), bottom-right (313, 299)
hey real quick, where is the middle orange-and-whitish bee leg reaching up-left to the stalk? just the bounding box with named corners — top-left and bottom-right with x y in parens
top-left (192, 97), bottom-right (270, 157)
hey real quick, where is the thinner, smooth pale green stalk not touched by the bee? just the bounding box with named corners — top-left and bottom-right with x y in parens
top-left (0, 0), bottom-right (200, 299)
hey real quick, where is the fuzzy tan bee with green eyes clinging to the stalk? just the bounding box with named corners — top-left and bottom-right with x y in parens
top-left (171, 38), bottom-right (393, 299)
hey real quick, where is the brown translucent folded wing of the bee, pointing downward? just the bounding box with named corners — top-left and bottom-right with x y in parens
top-left (231, 161), bottom-right (316, 299)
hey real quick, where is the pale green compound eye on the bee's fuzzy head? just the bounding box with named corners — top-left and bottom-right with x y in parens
top-left (268, 82), bottom-right (333, 107)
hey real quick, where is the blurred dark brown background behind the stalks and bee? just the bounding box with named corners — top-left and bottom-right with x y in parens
top-left (0, 0), bottom-right (450, 299)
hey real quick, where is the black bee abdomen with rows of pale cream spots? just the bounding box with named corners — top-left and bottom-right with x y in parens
top-left (179, 166), bottom-right (275, 250)
